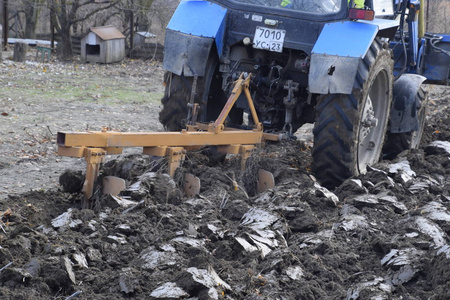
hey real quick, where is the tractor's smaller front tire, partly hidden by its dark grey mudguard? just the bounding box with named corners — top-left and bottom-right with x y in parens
top-left (383, 85), bottom-right (428, 159)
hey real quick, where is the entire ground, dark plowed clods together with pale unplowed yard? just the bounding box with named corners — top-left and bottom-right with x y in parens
top-left (0, 53), bottom-right (450, 300)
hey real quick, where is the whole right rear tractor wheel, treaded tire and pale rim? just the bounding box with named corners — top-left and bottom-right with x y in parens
top-left (312, 39), bottom-right (393, 188)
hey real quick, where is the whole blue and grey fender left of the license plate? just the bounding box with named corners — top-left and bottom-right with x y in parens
top-left (163, 1), bottom-right (227, 77)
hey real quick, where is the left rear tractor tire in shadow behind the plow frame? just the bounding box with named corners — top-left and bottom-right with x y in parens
top-left (159, 55), bottom-right (226, 131)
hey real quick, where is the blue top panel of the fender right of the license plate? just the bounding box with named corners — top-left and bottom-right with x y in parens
top-left (312, 21), bottom-right (378, 58)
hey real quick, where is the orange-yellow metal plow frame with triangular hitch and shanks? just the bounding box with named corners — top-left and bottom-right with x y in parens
top-left (57, 74), bottom-right (282, 208)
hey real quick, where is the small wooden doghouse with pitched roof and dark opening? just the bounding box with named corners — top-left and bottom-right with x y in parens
top-left (81, 26), bottom-right (125, 64)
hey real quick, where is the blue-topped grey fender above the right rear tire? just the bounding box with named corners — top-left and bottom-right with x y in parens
top-left (308, 19), bottom-right (398, 94)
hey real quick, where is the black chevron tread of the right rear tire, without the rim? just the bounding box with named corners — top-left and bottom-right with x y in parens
top-left (312, 39), bottom-right (392, 188)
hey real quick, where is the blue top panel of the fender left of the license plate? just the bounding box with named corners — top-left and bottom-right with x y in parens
top-left (167, 1), bottom-right (227, 38)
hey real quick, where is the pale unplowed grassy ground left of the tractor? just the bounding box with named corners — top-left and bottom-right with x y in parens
top-left (0, 53), bottom-right (163, 199)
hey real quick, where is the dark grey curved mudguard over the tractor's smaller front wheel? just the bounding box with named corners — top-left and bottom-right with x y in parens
top-left (389, 74), bottom-right (426, 133)
